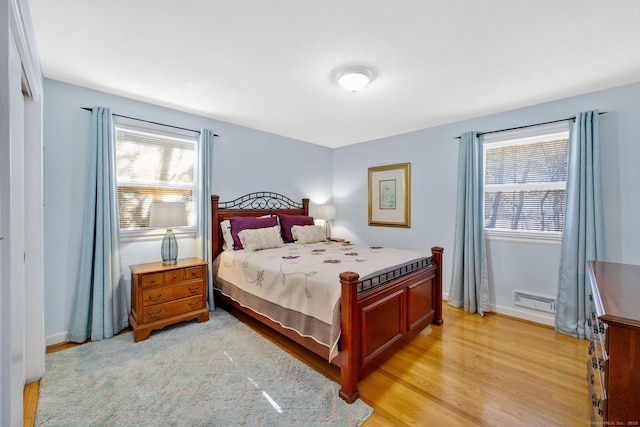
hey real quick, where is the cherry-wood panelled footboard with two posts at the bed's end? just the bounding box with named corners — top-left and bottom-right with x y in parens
top-left (340, 247), bottom-right (444, 402)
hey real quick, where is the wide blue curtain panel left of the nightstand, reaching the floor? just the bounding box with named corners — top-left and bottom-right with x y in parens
top-left (69, 107), bottom-right (128, 342)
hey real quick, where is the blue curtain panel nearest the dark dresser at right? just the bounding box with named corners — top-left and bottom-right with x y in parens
top-left (555, 110), bottom-right (605, 338)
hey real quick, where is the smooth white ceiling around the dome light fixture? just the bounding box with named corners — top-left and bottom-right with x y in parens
top-left (29, 0), bottom-right (640, 147)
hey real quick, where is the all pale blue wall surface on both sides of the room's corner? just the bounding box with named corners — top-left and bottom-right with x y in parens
top-left (44, 79), bottom-right (640, 344)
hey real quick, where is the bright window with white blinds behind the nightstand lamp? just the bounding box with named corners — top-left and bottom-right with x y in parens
top-left (116, 117), bottom-right (198, 231)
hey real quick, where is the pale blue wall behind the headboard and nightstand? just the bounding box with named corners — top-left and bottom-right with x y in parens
top-left (44, 79), bottom-right (332, 345)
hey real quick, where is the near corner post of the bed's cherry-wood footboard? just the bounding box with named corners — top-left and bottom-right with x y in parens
top-left (340, 271), bottom-right (360, 403)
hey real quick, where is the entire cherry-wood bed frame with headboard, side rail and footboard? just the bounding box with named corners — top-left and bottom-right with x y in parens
top-left (211, 192), bottom-right (444, 403)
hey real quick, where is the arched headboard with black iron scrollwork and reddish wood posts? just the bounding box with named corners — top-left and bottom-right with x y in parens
top-left (211, 191), bottom-right (309, 257)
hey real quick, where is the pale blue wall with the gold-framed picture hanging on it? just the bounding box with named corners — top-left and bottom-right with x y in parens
top-left (333, 83), bottom-right (640, 324)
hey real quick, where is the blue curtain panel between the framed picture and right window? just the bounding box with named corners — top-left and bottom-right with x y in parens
top-left (448, 132), bottom-right (489, 315)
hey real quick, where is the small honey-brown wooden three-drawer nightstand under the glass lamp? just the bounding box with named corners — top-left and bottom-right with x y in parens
top-left (129, 258), bottom-right (209, 342)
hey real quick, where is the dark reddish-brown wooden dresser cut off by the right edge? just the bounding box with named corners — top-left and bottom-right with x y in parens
top-left (587, 261), bottom-right (640, 426)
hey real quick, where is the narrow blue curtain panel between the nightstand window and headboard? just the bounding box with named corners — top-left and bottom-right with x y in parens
top-left (198, 129), bottom-right (216, 310)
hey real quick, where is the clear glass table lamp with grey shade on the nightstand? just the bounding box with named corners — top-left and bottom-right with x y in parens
top-left (149, 202), bottom-right (189, 265)
